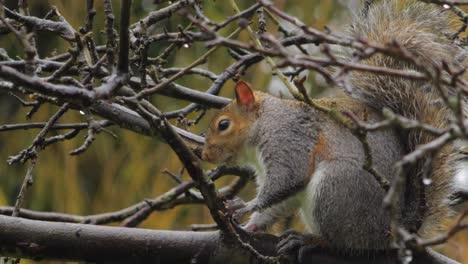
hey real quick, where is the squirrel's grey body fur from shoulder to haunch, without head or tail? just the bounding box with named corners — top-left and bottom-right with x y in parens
top-left (247, 97), bottom-right (403, 251)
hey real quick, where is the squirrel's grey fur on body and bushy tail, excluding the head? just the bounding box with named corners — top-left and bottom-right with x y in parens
top-left (222, 0), bottom-right (459, 254)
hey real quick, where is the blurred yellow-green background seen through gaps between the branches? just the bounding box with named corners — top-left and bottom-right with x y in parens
top-left (0, 0), bottom-right (468, 263)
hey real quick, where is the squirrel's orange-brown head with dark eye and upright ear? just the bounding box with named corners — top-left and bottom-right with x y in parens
top-left (202, 81), bottom-right (261, 163)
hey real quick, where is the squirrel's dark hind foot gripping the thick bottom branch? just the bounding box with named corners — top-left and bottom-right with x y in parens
top-left (276, 230), bottom-right (326, 263)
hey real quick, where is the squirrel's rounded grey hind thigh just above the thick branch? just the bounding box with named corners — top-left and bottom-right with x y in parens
top-left (312, 160), bottom-right (391, 251)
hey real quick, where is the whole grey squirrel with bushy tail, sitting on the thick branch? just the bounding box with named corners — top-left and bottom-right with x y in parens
top-left (202, 0), bottom-right (464, 252)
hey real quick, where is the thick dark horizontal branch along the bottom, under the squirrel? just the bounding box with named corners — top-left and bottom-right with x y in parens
top-left (0, 216), bottom-right (456, 264)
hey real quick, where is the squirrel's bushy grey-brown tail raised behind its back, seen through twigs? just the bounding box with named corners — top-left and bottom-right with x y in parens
top-left (350, 0), bottom-right (464, 234)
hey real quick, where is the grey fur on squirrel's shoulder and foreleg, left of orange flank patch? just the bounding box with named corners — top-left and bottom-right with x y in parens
top-left (247, 97), bottom-right (318, 211)
